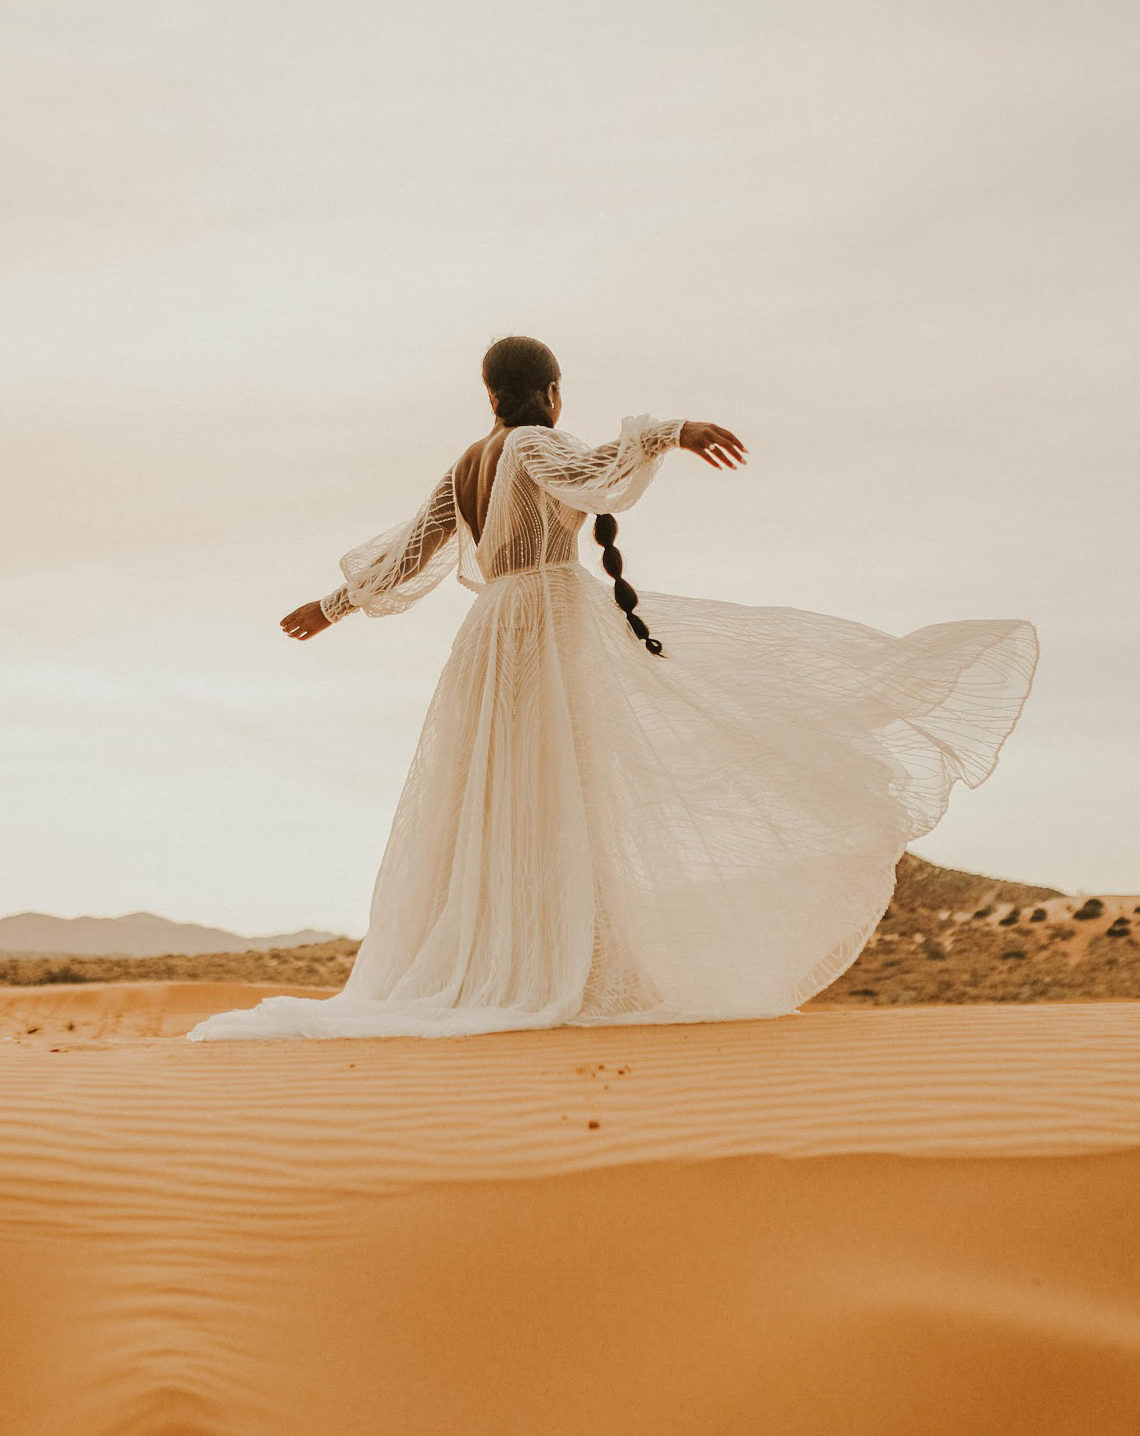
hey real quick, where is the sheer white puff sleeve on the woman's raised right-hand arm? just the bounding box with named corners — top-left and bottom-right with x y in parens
top-left (514, 414), bottom-right (685, 514)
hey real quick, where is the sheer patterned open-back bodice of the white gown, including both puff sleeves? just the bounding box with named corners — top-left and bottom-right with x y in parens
top-left (320, 414), bottom-right (685, 623)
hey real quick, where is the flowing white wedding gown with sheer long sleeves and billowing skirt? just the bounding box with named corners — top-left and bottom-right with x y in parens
top-left (182, 415), bottom-right (1038, 1041)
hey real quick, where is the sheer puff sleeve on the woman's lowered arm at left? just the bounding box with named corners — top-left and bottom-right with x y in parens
top-left (320, 470), bottom-right (458, 623)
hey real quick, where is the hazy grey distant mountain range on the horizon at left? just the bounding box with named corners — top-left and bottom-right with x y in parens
top-left (0, 912), bottom-right (339, 958)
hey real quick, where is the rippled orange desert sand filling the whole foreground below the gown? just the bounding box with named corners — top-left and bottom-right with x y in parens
top-left (0, 982), bottom-right (1140, 1436)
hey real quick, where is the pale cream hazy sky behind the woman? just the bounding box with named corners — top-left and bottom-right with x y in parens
top-left (0, 0), bottom-right (1140, 936)
